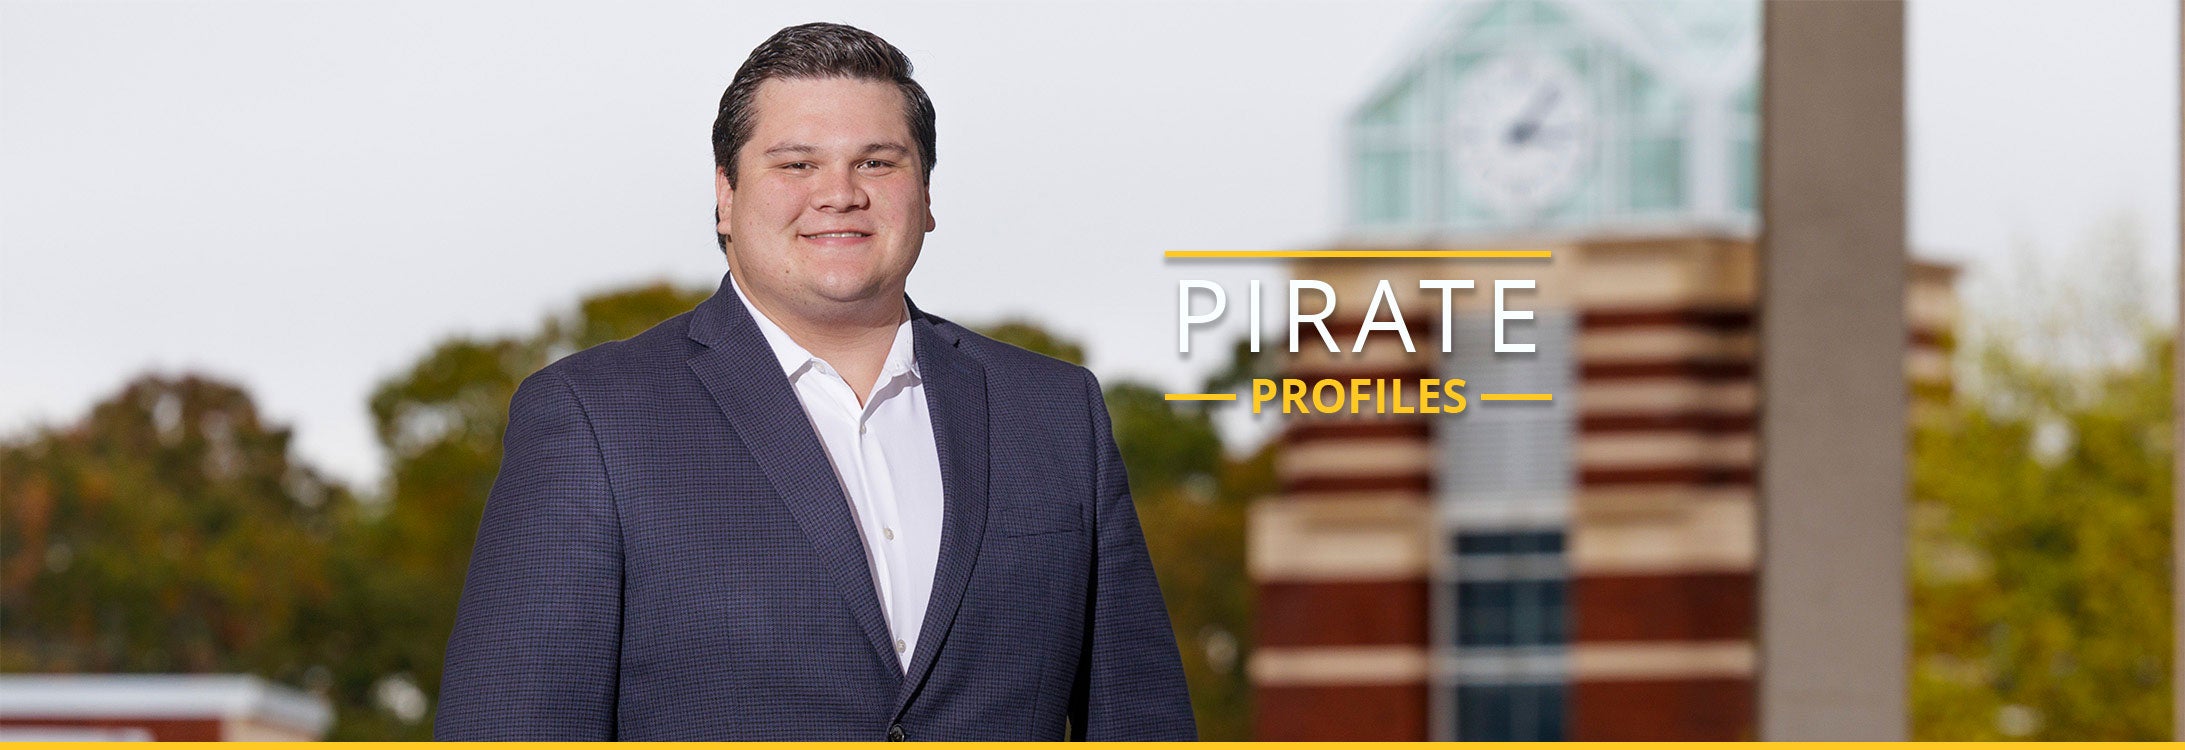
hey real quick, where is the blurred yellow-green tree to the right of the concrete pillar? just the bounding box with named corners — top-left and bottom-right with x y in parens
top-left (1912, 328), bottom-right (2176, 739)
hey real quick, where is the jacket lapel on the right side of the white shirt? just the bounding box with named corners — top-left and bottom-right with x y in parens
top-left (896, 306), bottom-right (988, 715)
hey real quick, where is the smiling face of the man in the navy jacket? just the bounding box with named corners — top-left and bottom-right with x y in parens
top-left (714, 79), bottom-right (933, 321)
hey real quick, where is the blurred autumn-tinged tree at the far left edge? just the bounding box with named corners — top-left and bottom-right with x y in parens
top-left (0, 376), bottom-right (358, 700)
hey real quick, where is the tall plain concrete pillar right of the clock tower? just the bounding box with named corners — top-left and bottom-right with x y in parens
top-left (1759, 0), bottom-right (1910, 741)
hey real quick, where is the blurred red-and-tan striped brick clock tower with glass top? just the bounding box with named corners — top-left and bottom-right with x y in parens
top-left (1248, 0), bottom-right (1956, 741)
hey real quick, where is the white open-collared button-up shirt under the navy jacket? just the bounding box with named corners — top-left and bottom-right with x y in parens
top-left (730, 276), bottom-right (942, 671)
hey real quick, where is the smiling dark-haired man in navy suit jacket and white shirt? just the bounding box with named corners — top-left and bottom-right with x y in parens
top-left (435, 24), bottom-right (1193, 739)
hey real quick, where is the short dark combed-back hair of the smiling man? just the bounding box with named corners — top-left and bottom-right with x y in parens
top-left (712, 24), bottom-right (933, 249)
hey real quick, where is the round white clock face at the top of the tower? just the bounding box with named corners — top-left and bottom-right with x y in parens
top-left (1449, 52), bottom-right (1593, 219)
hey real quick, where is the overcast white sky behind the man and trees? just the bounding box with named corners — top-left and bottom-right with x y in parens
top-left (0, 0), bottom-right (2178, 489)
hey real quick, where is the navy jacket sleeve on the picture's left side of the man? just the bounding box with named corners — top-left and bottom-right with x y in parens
top-left (433, 367), bottom-right (623, 741)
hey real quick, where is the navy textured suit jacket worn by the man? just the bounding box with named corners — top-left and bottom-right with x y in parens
top-left (433, 276), bottom-right (1195, 739)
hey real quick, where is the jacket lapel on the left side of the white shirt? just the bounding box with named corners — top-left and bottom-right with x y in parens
top-left (690, 276), bottom-right (913, 671)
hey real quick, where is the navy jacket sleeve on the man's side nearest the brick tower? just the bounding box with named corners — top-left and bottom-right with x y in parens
top-left (1071, 374), bottom-right (1200, 741)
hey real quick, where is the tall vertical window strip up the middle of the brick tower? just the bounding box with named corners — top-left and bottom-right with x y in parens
top-left (1433, 308), bottom-right (1578, 741)
